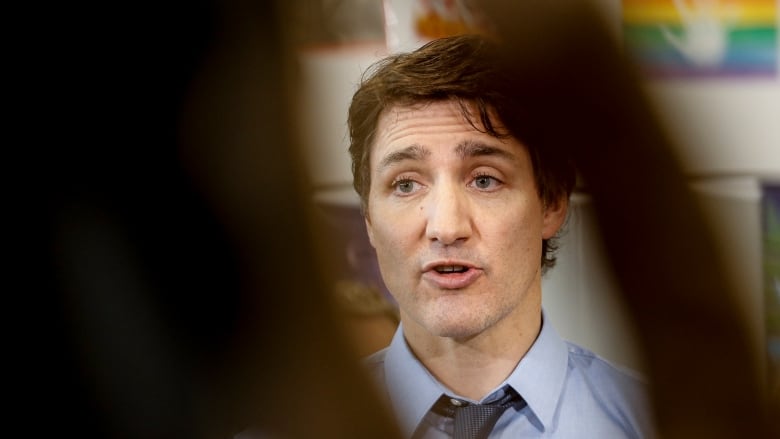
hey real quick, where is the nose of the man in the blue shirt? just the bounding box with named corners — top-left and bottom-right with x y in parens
top-left (425, 181), bottom-right (473, 245)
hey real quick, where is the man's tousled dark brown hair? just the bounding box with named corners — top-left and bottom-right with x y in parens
top-left (348, 35), bottom-right (575, 269)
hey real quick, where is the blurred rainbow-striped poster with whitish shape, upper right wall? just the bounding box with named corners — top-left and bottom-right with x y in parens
top-left (622, 0), bottom-right (778, 78)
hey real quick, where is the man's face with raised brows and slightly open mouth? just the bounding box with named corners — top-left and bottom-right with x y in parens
top-left (366, 101), bottom-right (566, 339)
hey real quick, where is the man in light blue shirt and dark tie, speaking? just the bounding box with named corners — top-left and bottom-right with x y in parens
top-left (349, 35), bottom-right (652, 438)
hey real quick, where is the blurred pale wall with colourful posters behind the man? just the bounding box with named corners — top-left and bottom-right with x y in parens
top-left (290, 0), bottom-right (780, 384)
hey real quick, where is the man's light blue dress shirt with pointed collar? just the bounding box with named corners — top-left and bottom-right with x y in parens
top-left (366, 318), bottom-right (654, 439)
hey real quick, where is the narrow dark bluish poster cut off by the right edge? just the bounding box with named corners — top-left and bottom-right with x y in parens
top-left (762, 184), bottom-right (780, 400)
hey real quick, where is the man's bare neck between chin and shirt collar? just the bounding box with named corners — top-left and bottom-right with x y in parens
top-left (404, 304), bottom-right (542, 401)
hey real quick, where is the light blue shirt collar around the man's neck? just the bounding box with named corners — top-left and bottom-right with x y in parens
top-left (384, 314), bottom-right (568, 437)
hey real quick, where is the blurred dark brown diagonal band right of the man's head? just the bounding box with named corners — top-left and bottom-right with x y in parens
top-left (485, 0), bottom-right (780, 439)
